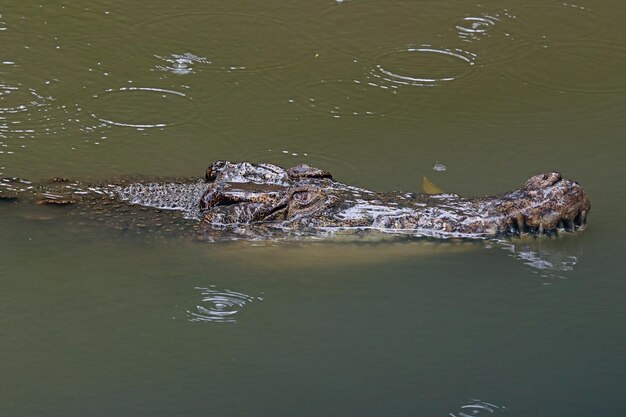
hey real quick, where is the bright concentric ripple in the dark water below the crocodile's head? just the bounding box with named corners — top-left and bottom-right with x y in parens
top-left (187, 287), bottom-right (263, 323)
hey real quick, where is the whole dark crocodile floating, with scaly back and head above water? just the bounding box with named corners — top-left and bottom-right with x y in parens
top-left (0, 160), bottom-right (591, 239)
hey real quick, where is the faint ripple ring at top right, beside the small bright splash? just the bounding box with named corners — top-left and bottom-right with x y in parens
top-left (497, 3), bottom-right (600, 41)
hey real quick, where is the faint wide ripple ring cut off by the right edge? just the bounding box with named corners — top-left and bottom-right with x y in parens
top-left (507, 41), bottom-right (626, 94)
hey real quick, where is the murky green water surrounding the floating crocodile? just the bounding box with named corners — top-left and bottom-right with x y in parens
top-left (0, 0), bottom-right (626, 416)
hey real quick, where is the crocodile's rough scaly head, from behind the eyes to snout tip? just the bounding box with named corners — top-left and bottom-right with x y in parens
top-left (200, 161), bottom-right (591, 237)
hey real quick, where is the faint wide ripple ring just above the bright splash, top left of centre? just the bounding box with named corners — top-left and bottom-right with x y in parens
top-left (141, 12), bottom-right (311, 72)
